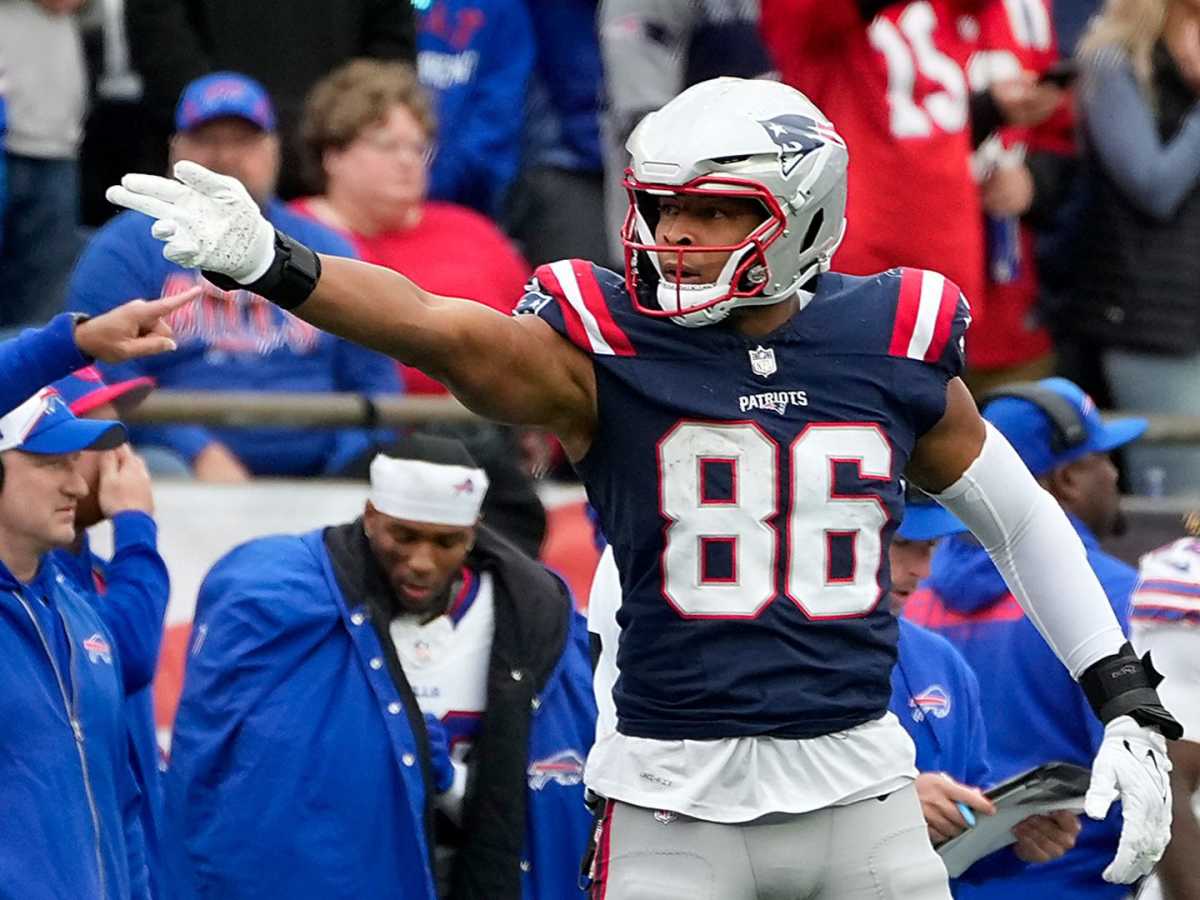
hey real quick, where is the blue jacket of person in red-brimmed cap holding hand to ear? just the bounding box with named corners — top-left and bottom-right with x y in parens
top-left (52, 511), bottom-right (170, 898)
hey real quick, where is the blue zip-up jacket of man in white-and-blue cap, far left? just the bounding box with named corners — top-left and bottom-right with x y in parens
top-left (0, 556), bottom-right (150, 900)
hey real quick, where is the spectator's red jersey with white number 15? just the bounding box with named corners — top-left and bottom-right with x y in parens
top-left (762, 0), bottom-right (991, 320)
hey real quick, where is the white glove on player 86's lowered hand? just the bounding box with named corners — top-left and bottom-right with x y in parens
top-left (1084, 715), bottom-right (1171, 884)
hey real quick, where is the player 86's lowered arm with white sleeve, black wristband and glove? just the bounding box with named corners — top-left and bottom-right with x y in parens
top-left (908, 378), bottom-right (1182, 882)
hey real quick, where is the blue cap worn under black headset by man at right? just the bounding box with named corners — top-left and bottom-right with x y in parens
top-left (983, 378), bottom-right (1148, 476)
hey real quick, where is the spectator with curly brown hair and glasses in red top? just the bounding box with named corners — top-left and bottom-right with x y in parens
top-left (294, 60), bottom-right (529, 394)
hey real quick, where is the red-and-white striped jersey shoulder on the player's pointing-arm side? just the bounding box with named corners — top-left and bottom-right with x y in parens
top-left (515, 259), bottom-right (637, 356)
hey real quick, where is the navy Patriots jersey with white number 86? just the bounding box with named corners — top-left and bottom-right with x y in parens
top-left (517, 260), bottom-right (970, 739)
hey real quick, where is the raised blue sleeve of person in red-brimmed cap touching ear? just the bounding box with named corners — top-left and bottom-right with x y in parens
top-left (97, 511), bottom-right (170, 694)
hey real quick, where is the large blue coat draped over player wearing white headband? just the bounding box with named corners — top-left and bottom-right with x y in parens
top-left (167, 530), bottom-right (595, 900)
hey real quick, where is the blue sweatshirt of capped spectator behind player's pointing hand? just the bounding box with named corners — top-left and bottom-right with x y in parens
top-left (67, 200), bottom-right (401, 475)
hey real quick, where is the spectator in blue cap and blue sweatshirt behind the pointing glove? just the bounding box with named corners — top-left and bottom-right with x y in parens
top-left (70, 72), bottom-right (400, 481)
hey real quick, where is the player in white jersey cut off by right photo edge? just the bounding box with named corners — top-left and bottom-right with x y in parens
top-left (1133, 538), bottom-right (1200, 900)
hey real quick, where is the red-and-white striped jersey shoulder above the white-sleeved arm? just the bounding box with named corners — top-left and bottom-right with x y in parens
top-left (888, 268), bottom-right (971, 362)
